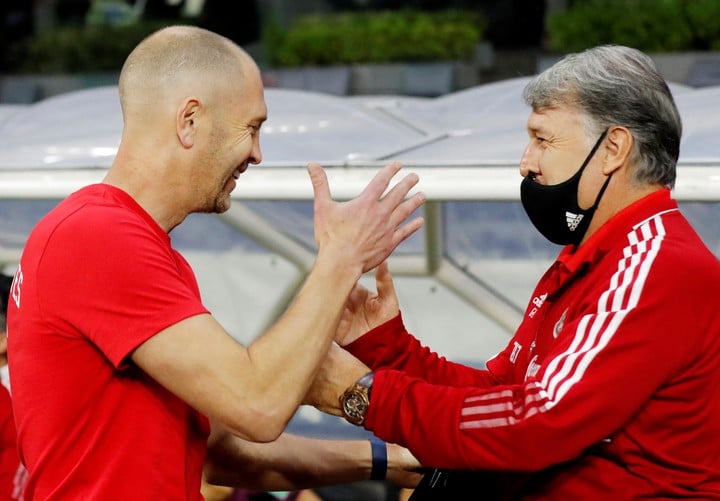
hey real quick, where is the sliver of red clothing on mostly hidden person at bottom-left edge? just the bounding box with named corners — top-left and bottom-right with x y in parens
top-left (0, 384), bottom-right (26, 500)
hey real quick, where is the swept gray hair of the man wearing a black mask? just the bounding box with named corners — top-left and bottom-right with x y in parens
top-left (523, 45), bottom-right (682, 187)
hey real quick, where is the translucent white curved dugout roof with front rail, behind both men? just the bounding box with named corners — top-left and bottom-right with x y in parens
top-left (0, 77), bottom-right (720, 199)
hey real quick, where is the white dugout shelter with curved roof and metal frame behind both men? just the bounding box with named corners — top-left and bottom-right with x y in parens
top-left (0, 77), bottom-right (720, 433)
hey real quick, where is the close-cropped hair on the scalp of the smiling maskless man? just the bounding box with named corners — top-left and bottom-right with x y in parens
top-left (119, 26), bottom-right (258, 122)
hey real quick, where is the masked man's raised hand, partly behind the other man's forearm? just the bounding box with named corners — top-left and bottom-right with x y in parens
top-left (335, 261), bottom-right (400, 346)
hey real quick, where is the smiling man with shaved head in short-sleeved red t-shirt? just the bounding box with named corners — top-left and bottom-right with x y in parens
top-left (8, 26), bottom-right (424, 501)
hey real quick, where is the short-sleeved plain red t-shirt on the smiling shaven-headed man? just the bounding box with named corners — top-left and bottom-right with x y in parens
top-left (8, 184), bottom-right (209, 500)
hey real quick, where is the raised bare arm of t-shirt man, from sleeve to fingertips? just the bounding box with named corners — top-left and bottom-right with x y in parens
top-left (132, 164), bottom-right (424, 442)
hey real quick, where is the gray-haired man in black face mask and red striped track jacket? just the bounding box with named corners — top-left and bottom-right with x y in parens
top-left (307, 46), bottom-right (720, 501)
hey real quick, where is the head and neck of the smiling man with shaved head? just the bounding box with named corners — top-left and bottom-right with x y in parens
top-left (109, 26), bottom-right (267, 231)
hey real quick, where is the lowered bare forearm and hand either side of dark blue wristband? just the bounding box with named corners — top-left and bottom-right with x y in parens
top-left (204, 426), bottom-right (420, 490)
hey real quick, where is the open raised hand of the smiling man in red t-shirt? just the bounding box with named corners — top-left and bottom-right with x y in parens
top-left (308, 162), bottom-right (425, 273)
